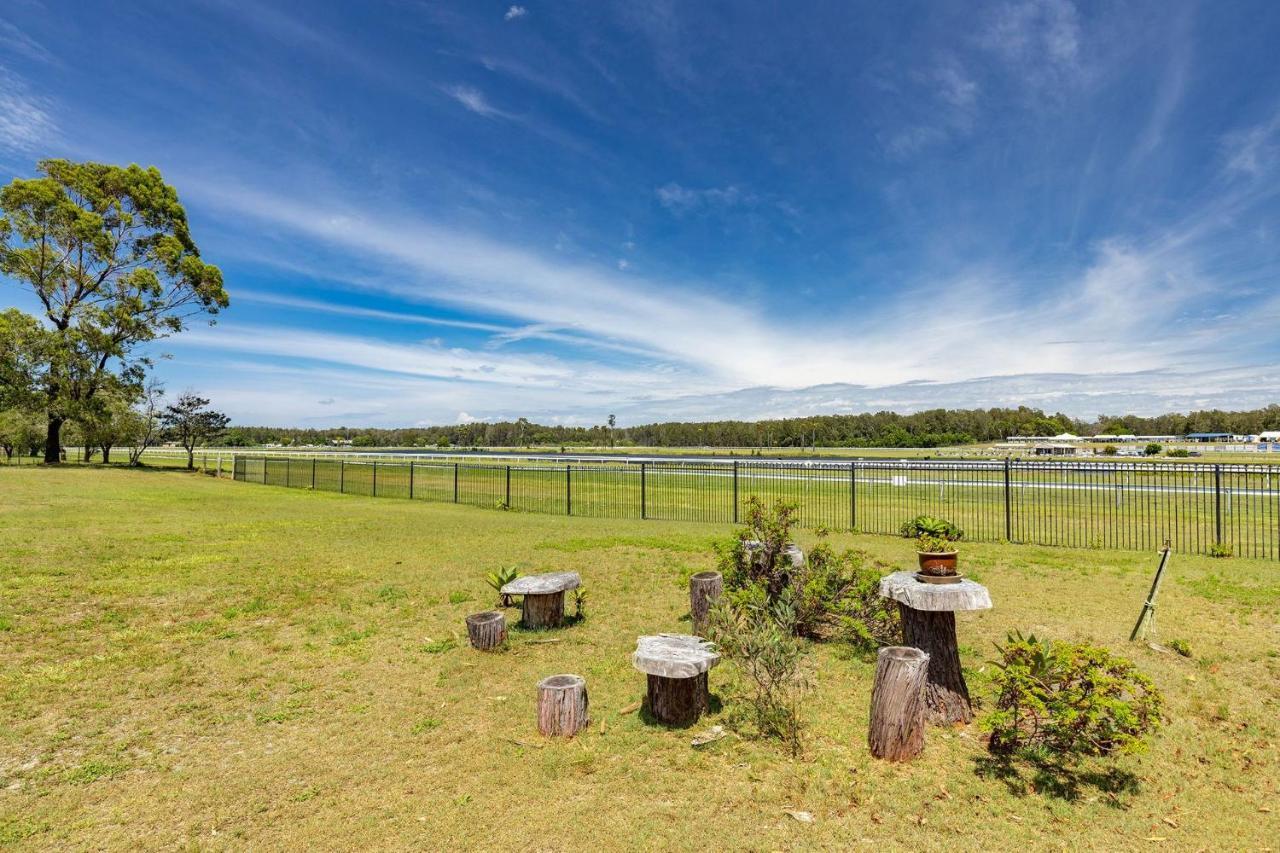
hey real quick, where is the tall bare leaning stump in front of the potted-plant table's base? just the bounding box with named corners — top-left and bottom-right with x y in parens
top-left (867, 646), bottom-right (929, 761)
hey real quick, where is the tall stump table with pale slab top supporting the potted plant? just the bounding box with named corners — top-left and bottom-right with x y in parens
top-left (881, 571), bottom-right (991, 725)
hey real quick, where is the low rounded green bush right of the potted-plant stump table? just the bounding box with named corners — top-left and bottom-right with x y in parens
top-left (983, 633), bottom-right (1164, 762)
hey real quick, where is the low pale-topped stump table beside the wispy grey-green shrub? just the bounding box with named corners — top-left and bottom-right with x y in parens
top-left (631, 634), bottom-right (719, 726)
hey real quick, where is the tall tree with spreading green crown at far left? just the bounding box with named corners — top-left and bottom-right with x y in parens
top-left (0, 160), bottom-right (228, 462)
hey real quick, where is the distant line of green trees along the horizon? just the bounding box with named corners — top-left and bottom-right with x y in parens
top-left (224, 405), bottom-right (1280, 448)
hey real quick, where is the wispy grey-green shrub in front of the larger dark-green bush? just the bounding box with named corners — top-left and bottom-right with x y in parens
top-left (708, 584), bottom-right (813, 754)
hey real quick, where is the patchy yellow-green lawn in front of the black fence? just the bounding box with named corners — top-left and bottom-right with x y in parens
top-left (0, 467), bottom-right (1280, 849)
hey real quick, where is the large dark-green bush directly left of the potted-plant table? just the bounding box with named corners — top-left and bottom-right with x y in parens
top-left (718, 496), bottom-right (900, 649)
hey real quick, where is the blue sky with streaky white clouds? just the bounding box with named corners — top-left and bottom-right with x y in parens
top-left (0, 0), bottom-right (1280, 427)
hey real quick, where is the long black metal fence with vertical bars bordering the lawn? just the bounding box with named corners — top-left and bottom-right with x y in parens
top-left (234, 456), bottom-right (1280, 558)
